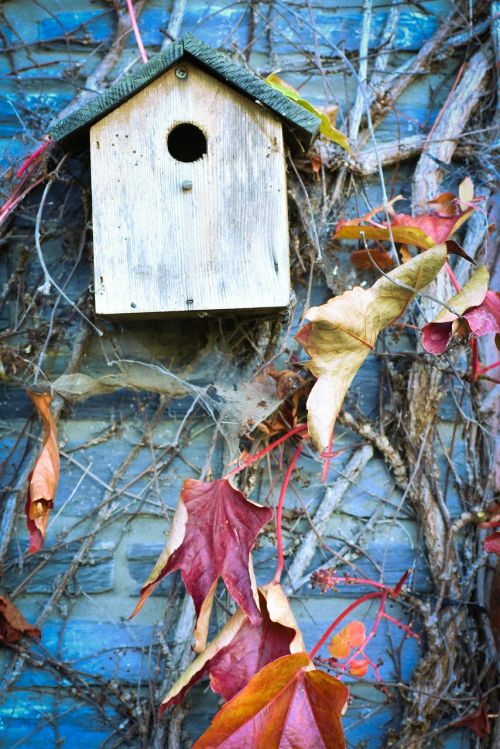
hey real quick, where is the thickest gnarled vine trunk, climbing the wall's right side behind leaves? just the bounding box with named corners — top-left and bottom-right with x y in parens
top-left (396, 33), bottom-right (496, 749)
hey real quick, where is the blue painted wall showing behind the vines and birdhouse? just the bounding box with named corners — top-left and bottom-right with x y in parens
top-left (0, 0), bottom-right (476, 749)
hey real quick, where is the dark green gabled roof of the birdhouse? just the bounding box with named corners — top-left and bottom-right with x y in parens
top-left (49, 34), bottom-right (320, 149)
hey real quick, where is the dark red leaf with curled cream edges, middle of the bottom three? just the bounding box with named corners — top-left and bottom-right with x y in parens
top-left (160, 583), bottom-right (304, 717)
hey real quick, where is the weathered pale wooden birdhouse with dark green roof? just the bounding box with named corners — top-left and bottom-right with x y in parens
top-left (51, 34), bottom-right (319, 316)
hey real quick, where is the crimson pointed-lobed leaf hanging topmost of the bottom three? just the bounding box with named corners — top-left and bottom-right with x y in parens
top-left (132, 479), bottom-right (273, 652)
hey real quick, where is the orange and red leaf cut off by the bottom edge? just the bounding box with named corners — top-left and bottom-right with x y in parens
top-left (193, 653), bottom-right (348, 749)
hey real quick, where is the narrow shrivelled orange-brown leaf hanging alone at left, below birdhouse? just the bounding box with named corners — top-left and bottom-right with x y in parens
top-left (25, 390), bottom-right (59, 554)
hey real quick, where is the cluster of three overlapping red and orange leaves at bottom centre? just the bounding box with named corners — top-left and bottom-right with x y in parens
top-left (129, 478), bottom-right (347, 749)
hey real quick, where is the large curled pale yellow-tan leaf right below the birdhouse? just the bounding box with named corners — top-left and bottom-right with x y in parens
top-left (297, 245), bottom-right (446, 450)
